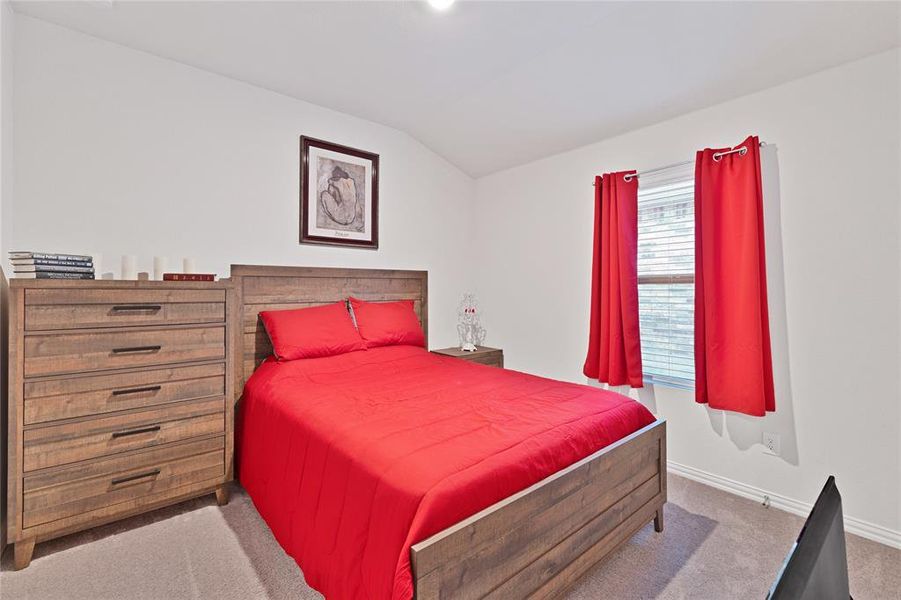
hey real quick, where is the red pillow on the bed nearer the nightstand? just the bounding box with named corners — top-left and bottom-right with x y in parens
top-left (350, 298), bottom-right (425, 348)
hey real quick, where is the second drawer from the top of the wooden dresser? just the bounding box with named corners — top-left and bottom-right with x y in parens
top-left (24, 326), bottom-right (225, 377)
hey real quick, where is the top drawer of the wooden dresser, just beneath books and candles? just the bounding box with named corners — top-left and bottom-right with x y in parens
top-left (25, 289), bottom-right (225, 331)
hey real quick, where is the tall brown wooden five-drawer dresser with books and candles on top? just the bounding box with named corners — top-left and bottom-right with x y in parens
top-left (7, 279), bottom-right (234, 569)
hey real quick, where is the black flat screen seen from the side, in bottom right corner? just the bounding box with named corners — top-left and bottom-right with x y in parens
top-left (767, 476), bottom-right (851, 600)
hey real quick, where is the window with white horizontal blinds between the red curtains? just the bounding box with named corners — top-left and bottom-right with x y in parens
top-left (638, 163), bottom-right (695, 389)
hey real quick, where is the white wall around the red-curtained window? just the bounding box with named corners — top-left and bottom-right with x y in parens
top-left (476, 51), bottom-right (901, 539)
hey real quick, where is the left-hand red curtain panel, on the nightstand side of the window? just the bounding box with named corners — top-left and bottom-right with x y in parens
top-left (582, 171), bottom-right (643, 387)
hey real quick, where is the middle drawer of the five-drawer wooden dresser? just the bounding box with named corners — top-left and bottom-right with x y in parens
top-left (24, 363), bottom-right (225, 425)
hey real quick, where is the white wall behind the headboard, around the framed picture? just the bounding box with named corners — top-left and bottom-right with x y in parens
top-left (12, 15), bottom-right (475, 346)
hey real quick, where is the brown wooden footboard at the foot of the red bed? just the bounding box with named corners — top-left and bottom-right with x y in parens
top-left (411, 420), bottom-right (666, 600)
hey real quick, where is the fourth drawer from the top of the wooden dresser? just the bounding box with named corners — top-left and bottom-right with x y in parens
top-left (23, 397), bottom-right (225, 472)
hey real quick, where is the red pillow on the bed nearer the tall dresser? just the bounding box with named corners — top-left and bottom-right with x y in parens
top-left (260, 302), bottom-right (366, 360)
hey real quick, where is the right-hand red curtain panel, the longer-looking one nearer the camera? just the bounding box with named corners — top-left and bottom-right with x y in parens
top-left (695, 136), bottom-right (776, 416)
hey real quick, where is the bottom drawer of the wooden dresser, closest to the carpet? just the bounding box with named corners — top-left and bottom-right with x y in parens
top-left (23, 437), bottom-right (225, 527)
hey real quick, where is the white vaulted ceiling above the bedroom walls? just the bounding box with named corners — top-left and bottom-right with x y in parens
top-left (14, 0), bottom-right (901, 176)
